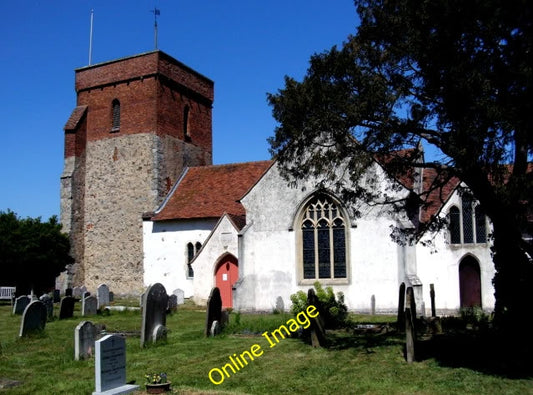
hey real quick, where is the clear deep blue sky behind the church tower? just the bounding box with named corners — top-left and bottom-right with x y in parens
top-left (0, 0), bottom-right (358, 220)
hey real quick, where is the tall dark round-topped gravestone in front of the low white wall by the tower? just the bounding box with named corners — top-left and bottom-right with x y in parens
top-left (141, 283), bottom-right (168, 347)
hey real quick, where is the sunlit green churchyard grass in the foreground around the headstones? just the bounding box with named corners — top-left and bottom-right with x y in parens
top-left (0, 301), bottom-right (533, 395)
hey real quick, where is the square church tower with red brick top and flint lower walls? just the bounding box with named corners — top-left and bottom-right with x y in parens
top-left (61, 51), bottom-right (213, 294)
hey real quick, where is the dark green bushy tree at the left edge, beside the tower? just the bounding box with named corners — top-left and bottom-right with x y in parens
top-left (0, 211), bottom-right (73, 294)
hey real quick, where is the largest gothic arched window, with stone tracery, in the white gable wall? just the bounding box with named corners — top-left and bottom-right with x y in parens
top-left (299, 194), bottom-right (348, 280)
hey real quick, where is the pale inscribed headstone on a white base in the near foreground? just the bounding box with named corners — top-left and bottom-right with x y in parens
top-left (93, 335), bottom-right (139, 395)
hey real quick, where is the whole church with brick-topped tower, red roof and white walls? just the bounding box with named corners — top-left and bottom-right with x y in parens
top-left (61, 50), bottom-right (494, 314)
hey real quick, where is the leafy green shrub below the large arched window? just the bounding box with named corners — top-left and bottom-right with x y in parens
top-left (290, 281), bottom-right (348, 329)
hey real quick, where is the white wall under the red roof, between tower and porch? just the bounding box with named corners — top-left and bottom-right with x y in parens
top-left (143, 220), bottom-right (216, 298)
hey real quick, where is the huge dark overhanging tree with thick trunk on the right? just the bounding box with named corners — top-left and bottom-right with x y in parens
top-left (268, 0), bottom-right (533, 330)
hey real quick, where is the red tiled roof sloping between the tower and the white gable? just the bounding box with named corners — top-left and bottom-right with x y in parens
top-left (152, 161), bottom-right (273, 226)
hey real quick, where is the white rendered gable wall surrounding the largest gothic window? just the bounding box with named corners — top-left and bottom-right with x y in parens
top-left (235, 165), bottom-right (404, 311)
